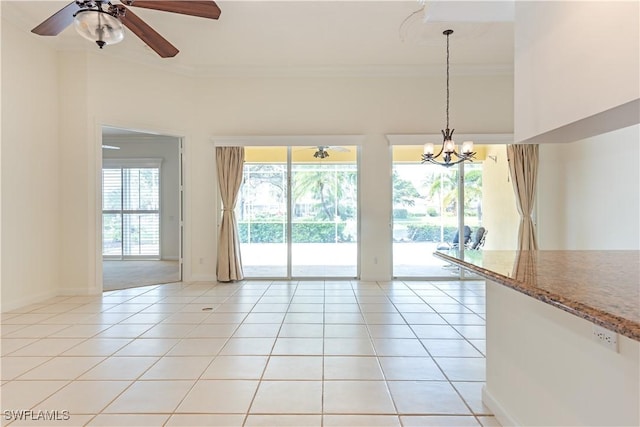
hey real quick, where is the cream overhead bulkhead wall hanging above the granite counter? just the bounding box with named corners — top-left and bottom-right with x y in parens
top-left (514, 1), bottom-right (640, 143)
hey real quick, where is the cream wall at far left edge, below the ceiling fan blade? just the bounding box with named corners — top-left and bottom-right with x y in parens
top-left (1, 19), bottom-right (61, 311)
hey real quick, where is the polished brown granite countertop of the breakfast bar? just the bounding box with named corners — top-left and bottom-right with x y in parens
top-left (435, 250), bottom-right (640, 341)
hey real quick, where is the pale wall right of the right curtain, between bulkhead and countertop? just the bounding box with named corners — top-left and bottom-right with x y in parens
top-left (537, 125), bottom-right (640, 250)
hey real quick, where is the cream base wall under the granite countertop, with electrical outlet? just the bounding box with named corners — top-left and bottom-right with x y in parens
top-left (483, 280), bottom-right (640, 426)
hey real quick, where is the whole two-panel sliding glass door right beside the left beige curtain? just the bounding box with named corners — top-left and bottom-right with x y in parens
top-left (236, 146), bottom-right (358, 278)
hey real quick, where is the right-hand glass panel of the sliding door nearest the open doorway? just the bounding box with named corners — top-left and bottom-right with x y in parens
top-left (291, 147), bottom-right (358, 277)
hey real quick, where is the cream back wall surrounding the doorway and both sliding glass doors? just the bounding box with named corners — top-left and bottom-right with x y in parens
top-left (2, 27), bottom-right (513, 308)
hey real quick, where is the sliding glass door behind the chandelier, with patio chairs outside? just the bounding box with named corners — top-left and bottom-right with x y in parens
top-left (392, 146), bottom-right (482, 278)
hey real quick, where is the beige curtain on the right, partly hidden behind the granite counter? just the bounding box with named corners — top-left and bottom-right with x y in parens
top-left (507, 144), bottom-right (538, 250)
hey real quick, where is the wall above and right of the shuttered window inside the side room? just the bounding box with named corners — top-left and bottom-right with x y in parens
top-left (102, 139), bottom-right (180, 260)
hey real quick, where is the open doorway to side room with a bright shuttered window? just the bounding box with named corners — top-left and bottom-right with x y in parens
top-left (102, 126), bottom-right (182, 291)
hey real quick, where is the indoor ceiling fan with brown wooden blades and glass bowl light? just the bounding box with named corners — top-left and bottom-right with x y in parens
top-left (31, 0), bottom-right (220, 58)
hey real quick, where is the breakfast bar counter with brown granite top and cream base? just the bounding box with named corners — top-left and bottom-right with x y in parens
top-left (435, 250), bottom-right (640, 426)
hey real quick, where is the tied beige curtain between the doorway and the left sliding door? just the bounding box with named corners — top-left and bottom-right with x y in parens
top-left (216, 147), bottom-right (244, 282)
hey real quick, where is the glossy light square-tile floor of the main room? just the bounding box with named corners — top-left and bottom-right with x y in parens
top-left (0, 281), bottom-right (498, 427)
